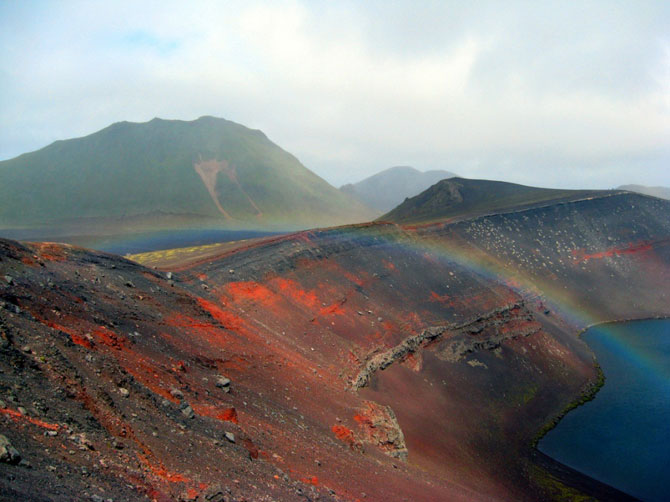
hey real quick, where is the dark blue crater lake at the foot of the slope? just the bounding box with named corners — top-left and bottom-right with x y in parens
top-left (538, 320), bottom-right (670, 501)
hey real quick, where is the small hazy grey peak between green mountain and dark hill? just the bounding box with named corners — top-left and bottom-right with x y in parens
top-left (340, 166), bottom-right (456, 213)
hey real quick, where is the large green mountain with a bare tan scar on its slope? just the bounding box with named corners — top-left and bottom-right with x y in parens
top-left (0, 117), bottom-right (373, 238)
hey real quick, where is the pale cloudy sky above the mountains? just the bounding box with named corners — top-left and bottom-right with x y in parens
top-left (0, 0), bottom-right (670, 188)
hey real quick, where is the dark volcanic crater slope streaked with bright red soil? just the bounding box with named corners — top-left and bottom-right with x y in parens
top-left (0, 191), bottom-right (670, 501)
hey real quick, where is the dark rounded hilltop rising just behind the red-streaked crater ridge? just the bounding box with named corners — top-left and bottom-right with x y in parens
top-left (379, 178), bottom-right (602, 223)
